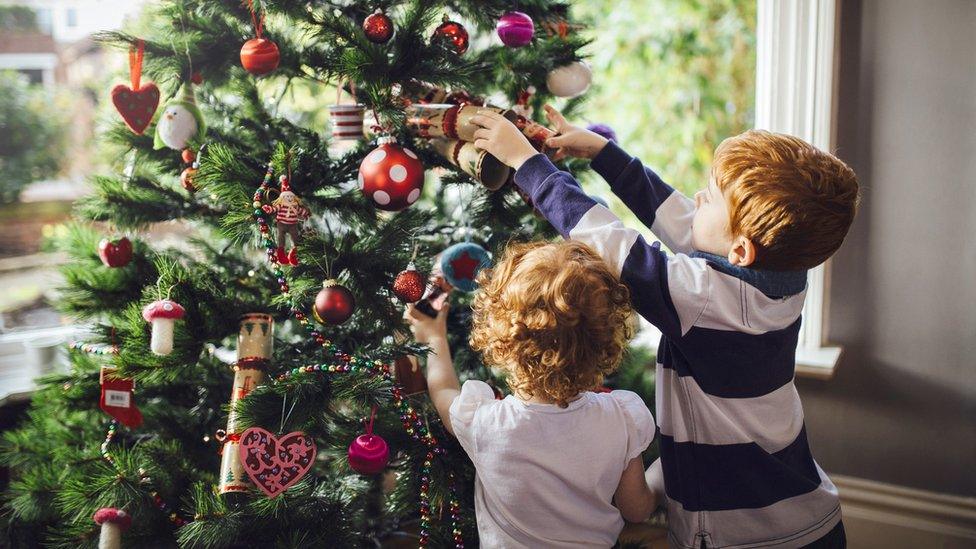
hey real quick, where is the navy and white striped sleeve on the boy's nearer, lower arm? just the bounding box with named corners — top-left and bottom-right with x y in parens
top-left (515, 154), bottom-right (687, 337)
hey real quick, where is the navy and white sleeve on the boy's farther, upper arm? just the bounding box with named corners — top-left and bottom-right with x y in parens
top-left (590, 141), bottom-right (695, 254)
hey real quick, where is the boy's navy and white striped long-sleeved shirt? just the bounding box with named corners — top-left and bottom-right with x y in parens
top-left (515, 143), bottom-right (840, 549)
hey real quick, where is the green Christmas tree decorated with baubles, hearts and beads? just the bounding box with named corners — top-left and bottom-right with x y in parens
top-left (2, 0), bottom-right (646, 547)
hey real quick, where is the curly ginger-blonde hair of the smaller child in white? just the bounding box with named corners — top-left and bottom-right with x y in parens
top-left (471, 241), bottom-right (634, 408)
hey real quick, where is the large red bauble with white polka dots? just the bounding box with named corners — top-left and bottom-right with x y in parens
top-left (359, 137), bottom-right (424, 212)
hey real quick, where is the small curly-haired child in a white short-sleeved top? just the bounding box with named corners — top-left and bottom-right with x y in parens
top-left (407, 241), bottom-right (656, 548)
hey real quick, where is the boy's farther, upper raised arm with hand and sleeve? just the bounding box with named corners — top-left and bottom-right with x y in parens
top-left (545, 105), bottom-right (695, 253)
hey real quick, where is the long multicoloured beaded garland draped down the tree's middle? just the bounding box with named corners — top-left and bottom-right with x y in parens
top-left (251, 164), bottom-right (464, 549)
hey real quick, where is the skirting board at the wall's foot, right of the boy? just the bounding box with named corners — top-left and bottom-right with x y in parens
top-left (830, 475), bottom-right (976, 549)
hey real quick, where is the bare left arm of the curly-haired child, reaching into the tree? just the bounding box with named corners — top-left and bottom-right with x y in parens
top-left (404, 303), bottom-right (461, 435)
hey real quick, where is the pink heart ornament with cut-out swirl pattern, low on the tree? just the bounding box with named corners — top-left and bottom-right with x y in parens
top-left (240, 427), bottom-right (315, 498)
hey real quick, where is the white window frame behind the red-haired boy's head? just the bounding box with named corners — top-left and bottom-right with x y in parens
top-left (755, 0), bottom-right (842, 379)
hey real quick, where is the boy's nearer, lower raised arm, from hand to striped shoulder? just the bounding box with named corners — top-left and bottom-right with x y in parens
top-left (472, 109), bottom-right (707, 337)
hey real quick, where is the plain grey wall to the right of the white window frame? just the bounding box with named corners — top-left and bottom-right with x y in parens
top-left (798, 0), bottom-right (976, 496)
